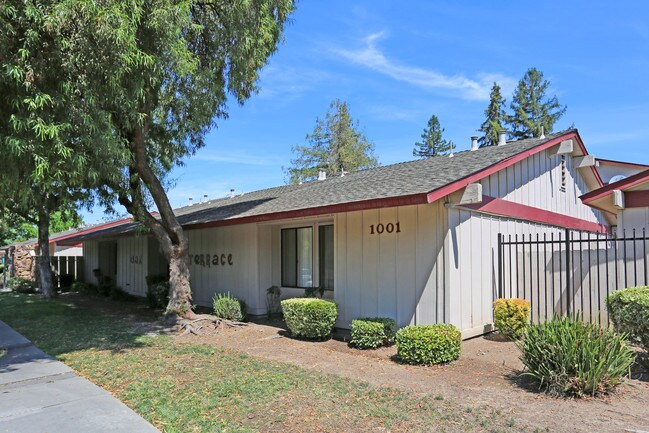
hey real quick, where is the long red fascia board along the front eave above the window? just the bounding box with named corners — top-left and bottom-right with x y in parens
top-left (183, 194), bottom-right (427, 230)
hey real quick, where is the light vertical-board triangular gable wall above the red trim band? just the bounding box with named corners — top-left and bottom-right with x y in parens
top-left (480, 151), bottom-right (606, 224)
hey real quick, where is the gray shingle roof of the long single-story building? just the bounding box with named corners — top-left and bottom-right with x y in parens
top-left (68, 131), bottom-right (572, 239)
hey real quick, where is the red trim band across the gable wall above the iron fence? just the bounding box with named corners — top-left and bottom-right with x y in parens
top-left (461, 196), bottom-right (608, 233)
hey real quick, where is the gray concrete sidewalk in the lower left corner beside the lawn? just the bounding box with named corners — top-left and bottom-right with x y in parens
top-left (0, 321), bottom-right (159, 433)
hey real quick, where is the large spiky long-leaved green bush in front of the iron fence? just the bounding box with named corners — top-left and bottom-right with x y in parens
top-left (517, 317), bottom-right (635, 396)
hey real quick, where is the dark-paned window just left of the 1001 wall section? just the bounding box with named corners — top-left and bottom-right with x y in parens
top-left (281, 225), bottom-right (334, 289)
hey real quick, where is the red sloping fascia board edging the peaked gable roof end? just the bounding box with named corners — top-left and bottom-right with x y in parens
top-left (428, 132), bottom-right (603, 203)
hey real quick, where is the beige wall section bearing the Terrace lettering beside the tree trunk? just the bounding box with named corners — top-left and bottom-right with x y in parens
top-left (187, 224), bottom-right (260, 314)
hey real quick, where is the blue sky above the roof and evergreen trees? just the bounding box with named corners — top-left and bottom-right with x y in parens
top-left (84, 0), bottom-right (649, 223)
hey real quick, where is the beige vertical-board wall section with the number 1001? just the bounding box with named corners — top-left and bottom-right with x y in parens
top-left (334, 202), bottom-right (448, 327)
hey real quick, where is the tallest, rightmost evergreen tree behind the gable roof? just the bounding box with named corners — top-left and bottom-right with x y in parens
top-left (508, 68), bottom-right (566, 139)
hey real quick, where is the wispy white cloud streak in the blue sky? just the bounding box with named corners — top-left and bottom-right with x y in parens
top-left (333, 32), bottom-right (516, 100)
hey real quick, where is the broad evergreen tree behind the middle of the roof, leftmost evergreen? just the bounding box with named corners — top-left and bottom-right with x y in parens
top-left (285, 99), bottom-right (379, 183)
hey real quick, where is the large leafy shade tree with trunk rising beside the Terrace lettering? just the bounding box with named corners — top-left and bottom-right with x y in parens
top-left (57, 0), bottom-right (294, 316)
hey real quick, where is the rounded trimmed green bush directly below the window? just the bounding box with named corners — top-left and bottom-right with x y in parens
top-left (282, 298), bottom-right (338, 340)
